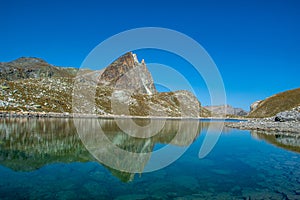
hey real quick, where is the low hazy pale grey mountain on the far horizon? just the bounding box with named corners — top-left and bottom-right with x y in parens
top-left (204, 105), bottom-right (248, 116)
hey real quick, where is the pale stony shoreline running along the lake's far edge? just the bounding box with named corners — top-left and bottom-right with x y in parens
top-left (0, 111), bottom-right (300, 135)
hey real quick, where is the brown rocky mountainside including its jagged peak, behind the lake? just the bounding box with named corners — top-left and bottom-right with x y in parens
top-left (0, 53), bottom-right (210, 117)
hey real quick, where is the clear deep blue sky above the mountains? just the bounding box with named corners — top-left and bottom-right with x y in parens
top-left (0, 0), bottom-right (300, 109)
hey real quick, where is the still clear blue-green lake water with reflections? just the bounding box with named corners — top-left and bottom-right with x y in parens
top-left (0, 119), bottom-right (300, 199)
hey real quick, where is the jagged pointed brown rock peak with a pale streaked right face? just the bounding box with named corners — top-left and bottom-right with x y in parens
top-left (99, 52), bottom-right (157, 95)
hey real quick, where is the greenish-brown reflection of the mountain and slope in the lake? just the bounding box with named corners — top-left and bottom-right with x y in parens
top-left (0, 118), bottom-right (204, 182)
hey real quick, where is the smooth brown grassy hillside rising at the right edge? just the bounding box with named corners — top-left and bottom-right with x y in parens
top-left (249, 88), bottom-right (300, 118)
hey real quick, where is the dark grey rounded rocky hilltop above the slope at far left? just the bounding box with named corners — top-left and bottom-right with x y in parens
top-left (0, 57), bottom-right (78, 81)
